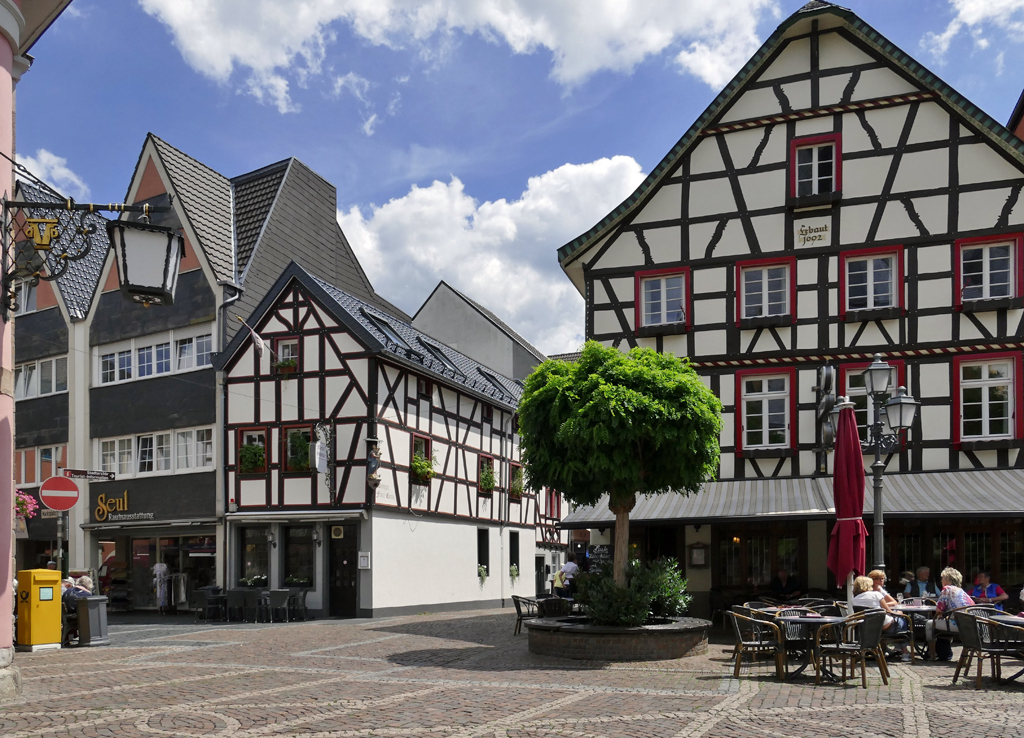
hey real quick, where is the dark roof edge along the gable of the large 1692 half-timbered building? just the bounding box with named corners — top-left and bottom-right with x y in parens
top-left (558, 0), bottom-right (1024, 268)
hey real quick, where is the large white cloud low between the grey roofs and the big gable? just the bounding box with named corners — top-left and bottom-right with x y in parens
top-left (338, 157), bottom-right (644, 353)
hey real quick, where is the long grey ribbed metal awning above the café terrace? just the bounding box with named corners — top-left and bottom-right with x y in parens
top-left (561, 469), bottom-right (1024, 528)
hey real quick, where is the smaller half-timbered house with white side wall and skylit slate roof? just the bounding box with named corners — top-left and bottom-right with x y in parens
top-left (218, 264), bottom-right (564, 616)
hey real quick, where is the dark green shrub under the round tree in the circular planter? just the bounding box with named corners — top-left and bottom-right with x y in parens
top-left (575, 559), bottom-right (691, 627)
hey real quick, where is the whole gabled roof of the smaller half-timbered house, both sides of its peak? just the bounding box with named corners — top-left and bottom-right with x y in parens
top-left (215, 261), bottom-right (522, 409)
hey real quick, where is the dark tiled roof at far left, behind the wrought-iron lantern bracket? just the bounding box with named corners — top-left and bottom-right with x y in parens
top-left (17, 180), bottom-right (111, 321)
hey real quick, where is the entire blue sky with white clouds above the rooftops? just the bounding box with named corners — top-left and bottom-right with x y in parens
top-left (16, 0), bottom-right (1024, 353)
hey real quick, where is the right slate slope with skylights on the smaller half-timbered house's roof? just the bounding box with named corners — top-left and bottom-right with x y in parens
top-left (309, 272), bottom-right (522, 408)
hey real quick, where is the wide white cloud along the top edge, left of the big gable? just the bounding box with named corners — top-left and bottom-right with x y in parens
top-left (138, 0), bottom-right (774, 113)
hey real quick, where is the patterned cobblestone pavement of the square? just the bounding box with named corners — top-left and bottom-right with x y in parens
top-left (0, 610), bottom-right (1024, 738)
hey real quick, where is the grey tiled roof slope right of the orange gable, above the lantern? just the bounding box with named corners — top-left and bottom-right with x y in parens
top-left (148, 133), bottom-right (234, 283)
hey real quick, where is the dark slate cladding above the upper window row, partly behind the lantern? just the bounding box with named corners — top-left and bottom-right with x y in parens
top-left (89, 269), bottom-right (217, 346)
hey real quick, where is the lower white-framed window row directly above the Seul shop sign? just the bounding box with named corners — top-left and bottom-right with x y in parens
top-left (99, 428), bottom-right (213, 476)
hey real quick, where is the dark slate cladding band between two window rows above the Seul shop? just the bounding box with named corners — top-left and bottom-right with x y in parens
top-left (89, 368), bottom-right (216, 438)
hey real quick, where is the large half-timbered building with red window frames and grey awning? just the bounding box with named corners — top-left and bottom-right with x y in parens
top-left (558, 1), bottom-right (1024, 608)
